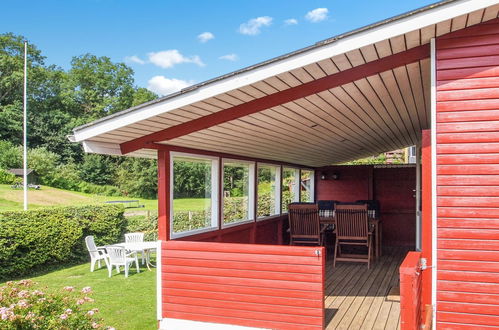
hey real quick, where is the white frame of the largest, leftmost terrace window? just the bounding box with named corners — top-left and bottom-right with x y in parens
top-left (170, 152), bottom-right (220, 239)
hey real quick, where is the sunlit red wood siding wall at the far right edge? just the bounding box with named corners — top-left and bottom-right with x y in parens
top-left (436, 19), bottom-right (499, 328)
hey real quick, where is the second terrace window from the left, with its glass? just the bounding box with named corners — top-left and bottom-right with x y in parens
top-left (223, 160), bottom-right (255, 224)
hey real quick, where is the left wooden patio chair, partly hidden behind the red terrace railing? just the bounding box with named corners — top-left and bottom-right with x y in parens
top-left (288, 203), bottom-right (324, 245)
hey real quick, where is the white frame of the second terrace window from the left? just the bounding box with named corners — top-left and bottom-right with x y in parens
top-left (219, 158), bottom-right (256, 229)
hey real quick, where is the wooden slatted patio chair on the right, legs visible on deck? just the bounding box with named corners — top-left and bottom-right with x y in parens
top-left (333, 204), bottom-right (373, 269)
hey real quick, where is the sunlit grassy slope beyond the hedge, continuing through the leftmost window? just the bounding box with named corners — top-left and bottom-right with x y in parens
top-left (0, 184), bottom-right (204, 211)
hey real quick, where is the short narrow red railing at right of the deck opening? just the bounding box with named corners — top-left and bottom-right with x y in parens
top-left (399, 251), bottom-right (422, 330)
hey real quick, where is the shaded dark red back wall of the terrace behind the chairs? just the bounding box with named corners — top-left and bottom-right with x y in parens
top-left (316, 165), bottom-right (416, 246)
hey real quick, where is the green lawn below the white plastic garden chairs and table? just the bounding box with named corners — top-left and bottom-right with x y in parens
top-left (26, 263), bottom-right (157, 330)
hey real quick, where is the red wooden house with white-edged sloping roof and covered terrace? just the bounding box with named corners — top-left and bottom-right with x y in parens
top-left (70, 0), bottom-right (499, 329)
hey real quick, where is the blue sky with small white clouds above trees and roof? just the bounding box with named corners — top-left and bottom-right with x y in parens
top-left (0, 0), bottom-right (436, 94)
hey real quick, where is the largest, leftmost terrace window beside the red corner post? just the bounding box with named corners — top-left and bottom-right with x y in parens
top-left (171, 155), bottom-right (218, 236)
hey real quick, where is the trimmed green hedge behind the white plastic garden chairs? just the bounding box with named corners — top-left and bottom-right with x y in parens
top-left (0, 205), bottom-right (127, 279)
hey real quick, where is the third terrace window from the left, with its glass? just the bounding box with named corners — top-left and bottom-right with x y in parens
top-left (256, 164), bottom-right (281, 218)
